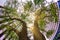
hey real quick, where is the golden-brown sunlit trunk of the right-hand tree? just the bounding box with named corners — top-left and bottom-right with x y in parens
top-left (32, 17), bottom-right (46, 40)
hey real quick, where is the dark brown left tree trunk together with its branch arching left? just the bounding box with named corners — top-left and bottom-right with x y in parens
top-left (11, 18), bottom-right (30, 40)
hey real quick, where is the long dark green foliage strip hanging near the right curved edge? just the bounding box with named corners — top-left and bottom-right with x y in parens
top-left (50, 3), bottom-right (58, 22)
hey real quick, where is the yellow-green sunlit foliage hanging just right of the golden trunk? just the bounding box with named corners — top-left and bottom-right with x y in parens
top-left (35, 9), bottom-right (47, 31)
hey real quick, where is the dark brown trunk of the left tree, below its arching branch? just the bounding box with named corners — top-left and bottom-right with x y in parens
top-left (19, 23), bottom-right (30, 40)
